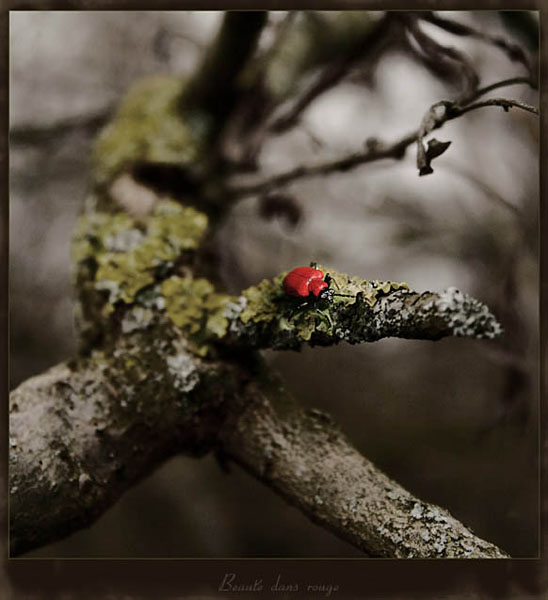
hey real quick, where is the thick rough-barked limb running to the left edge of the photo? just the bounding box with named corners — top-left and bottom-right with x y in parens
top-left (10, 340), bottom-right (240, 555)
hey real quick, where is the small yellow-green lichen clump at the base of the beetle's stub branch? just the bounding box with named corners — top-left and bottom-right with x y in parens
top-left (161, 275), bottom-right (231, 355)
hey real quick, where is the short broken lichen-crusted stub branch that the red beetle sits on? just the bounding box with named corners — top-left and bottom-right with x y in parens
top-left (220, 271), bottom-right (501, 350)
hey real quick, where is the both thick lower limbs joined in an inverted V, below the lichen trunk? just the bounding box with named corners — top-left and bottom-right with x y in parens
top-left (10, 352), bottom-right (506, 558)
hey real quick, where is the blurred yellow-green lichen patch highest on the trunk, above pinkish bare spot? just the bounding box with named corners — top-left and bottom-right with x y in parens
top-left (93, 75), bottom-right (205, 184)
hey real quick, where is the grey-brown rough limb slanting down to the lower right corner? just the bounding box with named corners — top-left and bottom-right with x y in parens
top-left (220, 372), bottom-right (508, 558)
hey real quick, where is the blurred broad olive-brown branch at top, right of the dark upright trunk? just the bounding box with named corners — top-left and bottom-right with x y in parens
top-left (220, 11), bottom-right (397, 171)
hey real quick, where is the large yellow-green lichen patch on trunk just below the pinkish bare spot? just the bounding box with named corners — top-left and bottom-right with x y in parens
top-left (73, 200), bottom-right (207, 314)
